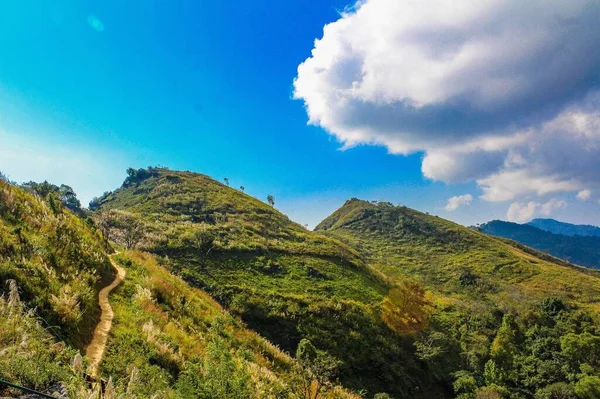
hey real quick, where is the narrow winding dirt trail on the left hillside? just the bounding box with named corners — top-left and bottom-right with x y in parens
top-left (85, 256), bottom-right (125, 377)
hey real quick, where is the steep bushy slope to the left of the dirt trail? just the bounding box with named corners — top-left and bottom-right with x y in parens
top-left (0, 180), bottom-right (112, 397)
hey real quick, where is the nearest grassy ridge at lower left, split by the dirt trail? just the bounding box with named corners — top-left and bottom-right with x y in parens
top-left (0, 179), bottom-right (357, 399)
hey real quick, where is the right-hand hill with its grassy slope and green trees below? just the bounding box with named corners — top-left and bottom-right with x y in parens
top-left (316, 199), bottom-right (600, 398)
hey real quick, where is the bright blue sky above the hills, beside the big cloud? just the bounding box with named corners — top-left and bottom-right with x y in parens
top-left (0, 0), bottom-right (600, 226)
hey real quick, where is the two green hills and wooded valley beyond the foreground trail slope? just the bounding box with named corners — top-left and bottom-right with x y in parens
top-left (92, 170), bottom-right (600, 398)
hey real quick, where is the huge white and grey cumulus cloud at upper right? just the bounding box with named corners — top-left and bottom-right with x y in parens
top-left (294, 0), bottom-right (600, 201)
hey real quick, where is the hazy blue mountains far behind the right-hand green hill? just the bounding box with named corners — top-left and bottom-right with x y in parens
top-left (480, 219), bottom-right (600, 268)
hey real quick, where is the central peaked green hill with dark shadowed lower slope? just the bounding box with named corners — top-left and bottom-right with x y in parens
top-left (94, 168), bottom-right (445, 398)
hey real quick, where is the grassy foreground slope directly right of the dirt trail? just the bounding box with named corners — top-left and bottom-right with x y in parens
top-left (101, 251), bottom-right (352, 399)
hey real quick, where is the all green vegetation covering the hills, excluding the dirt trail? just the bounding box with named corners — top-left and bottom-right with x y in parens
top-left (0, 168), bottom-right (600, 399)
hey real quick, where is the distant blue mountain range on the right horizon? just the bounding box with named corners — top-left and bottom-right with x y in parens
top-left (479, 219), bottom-right (600, 268)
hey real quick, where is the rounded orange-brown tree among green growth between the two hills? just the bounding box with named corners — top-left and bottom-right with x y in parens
top-left (382, 282), bottom-right (431, 335)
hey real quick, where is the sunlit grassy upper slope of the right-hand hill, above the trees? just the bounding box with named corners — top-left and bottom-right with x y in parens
top-left (317, 200), bottom-right (600, 310)
